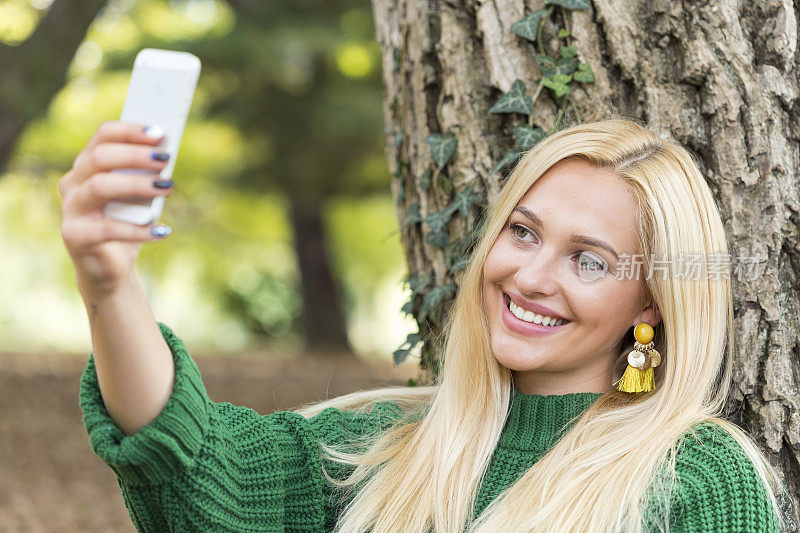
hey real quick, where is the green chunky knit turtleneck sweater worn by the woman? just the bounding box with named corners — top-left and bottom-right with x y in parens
top-left (80, 324), bottom-right (778, 532)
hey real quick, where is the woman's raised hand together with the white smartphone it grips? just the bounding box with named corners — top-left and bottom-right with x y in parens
top-left (58, 50), bottom-right (199, 295)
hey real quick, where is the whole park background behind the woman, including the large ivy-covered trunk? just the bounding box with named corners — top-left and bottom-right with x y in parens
top-left (0, 0), bottom-right (800, 531)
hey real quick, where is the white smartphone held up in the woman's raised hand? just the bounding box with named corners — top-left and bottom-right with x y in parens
top-left (103, 48), bottom-right (200, 226)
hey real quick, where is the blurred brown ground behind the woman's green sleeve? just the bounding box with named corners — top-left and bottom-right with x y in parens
top-left (0, 354), bottom-right (416, 533)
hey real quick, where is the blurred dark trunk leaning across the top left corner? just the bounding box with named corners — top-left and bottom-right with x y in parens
top-left (0, 0), bottom-right (106, 173)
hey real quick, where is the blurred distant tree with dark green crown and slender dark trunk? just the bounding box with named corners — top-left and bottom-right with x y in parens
top-left (190, 0), bottom-right (388, 349)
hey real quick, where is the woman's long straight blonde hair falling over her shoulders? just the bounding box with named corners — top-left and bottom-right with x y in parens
top-left (297, 117), bottom-right (784, 533)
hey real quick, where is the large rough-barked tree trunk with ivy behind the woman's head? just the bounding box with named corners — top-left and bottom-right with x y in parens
top-left (373, 0), bottom-right (800, 531)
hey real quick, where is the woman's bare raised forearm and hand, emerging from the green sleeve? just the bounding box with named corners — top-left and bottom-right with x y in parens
top-left (58, 122), bottom-right (174, 435)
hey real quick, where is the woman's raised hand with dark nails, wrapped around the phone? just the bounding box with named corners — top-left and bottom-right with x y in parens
top-left (58, 122), bottom-right (173, 293)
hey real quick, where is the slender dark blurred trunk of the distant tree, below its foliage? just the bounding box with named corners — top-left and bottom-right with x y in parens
top-left (290, 197), bottom-right (350, 352)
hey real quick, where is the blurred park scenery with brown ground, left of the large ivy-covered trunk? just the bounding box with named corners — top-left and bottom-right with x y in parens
top-left (0, 0), bottom-right (415, 531)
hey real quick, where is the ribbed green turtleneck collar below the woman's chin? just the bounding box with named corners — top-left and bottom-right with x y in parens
top-left (498, 387), bottom-right (602, 453)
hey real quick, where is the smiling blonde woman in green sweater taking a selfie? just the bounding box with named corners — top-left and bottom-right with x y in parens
top-left (60, 118), bottom-right (783, 532)
